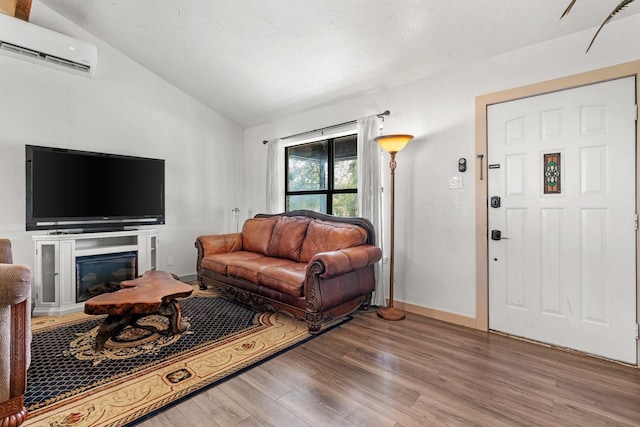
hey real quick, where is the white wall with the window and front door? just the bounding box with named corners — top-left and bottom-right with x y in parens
top-left (242, 15), bottom-right (640, 317)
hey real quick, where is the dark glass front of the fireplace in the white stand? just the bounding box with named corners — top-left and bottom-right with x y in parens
top-left (76, 251), bottom-right (138, 302)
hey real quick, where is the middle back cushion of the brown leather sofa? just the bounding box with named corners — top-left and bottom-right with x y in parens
top-left (267, 216), bottom-right (311, 262)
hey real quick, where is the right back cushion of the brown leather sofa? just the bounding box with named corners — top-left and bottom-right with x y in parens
top-left (300, 219), bottom-right (367, 262)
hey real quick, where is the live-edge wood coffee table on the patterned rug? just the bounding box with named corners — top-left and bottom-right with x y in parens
top-left (84, 270), bottom-right (193, 351)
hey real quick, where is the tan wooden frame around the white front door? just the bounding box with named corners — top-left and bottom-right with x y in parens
top-left (475, 61), bottom-right (640, 367)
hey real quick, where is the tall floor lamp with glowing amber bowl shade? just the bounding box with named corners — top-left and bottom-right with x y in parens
top-left (373, 135), bottom-right (413, 320)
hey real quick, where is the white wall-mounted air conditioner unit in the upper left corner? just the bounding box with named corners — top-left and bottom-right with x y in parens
top-left (0, 13), bottom-right (98, 77)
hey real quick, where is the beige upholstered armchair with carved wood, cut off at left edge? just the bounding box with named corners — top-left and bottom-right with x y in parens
top-left (0, 239), bottom-right (31, 427)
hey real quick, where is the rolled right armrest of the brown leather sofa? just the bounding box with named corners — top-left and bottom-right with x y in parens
top-left (309, 245), bottom-right (382, 279)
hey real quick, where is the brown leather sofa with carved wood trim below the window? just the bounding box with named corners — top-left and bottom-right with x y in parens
top-left (195, 210), bottom-right (382, 333)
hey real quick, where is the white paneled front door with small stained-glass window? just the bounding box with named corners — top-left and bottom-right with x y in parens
top-left (487, 77), bottom-right (637, 364)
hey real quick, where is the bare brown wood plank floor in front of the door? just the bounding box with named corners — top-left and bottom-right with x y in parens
top-left (140, 312), bottom-right (640, 427)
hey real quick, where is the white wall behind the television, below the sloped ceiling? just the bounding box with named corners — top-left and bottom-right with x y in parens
top-left (0, 2), bottom-right (243, 276)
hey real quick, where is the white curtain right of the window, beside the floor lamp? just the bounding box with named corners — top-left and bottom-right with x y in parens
top-left (357, 116), bottom-right (386, 306)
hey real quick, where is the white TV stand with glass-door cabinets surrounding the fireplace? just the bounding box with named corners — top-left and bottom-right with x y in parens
top-left (32, 230), bottom-right (159, 316)
